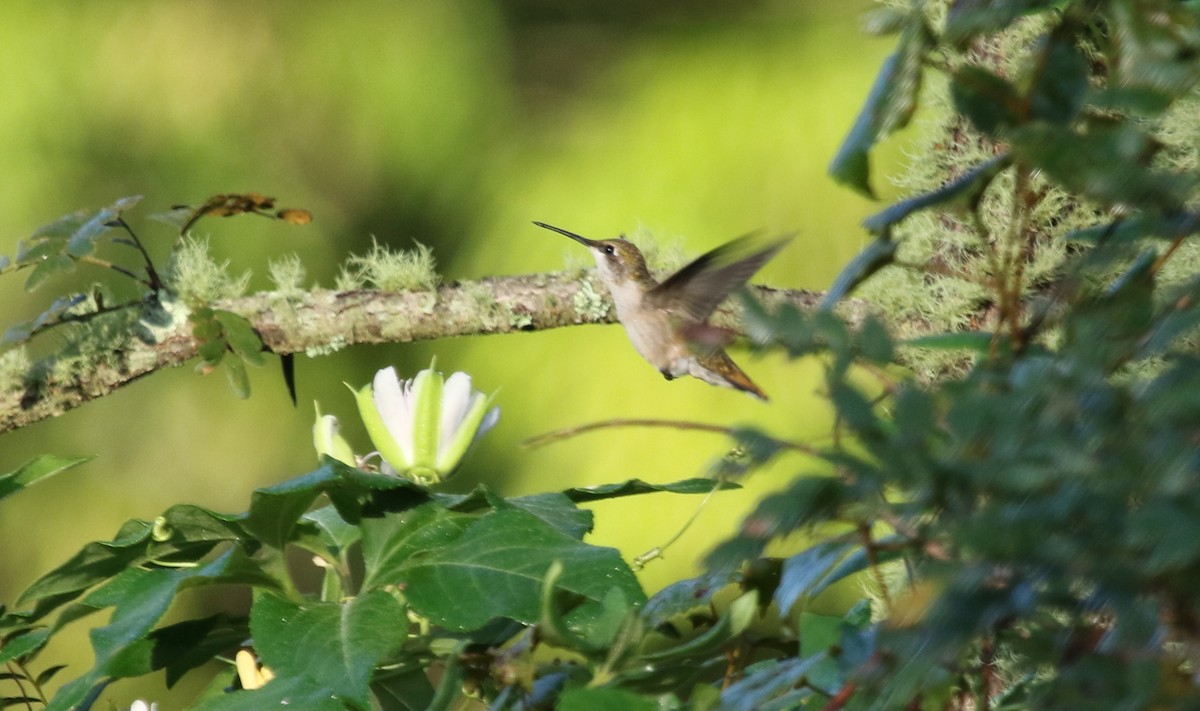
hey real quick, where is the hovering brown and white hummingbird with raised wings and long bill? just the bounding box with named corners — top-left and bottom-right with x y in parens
top-left (534, 222), bottom-right (788, 400)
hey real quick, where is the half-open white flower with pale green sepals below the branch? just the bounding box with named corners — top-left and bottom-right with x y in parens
top-left (355, 368), bottom-right (500, 484)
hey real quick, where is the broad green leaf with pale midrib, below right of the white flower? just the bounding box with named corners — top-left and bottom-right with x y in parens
top-left (404, 509), bottom-right (646, 629)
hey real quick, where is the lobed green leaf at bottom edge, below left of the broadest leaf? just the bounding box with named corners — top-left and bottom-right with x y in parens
top-left (250, 591), bottom-right (408, 709)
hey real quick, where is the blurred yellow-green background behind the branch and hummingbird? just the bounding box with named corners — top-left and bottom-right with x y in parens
top-left (0, 0), bottom-right (896, 707)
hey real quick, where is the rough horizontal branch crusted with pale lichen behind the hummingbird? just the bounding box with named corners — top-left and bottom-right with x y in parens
top-left (0, 271), bottom-right (844, 432)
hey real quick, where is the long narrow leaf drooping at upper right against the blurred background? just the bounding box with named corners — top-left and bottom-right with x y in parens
top-left (829, 11), bottom-right (932, 197)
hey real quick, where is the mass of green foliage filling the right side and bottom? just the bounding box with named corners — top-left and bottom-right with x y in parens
top-left (0, 0), bottom-right (1200, 710)
